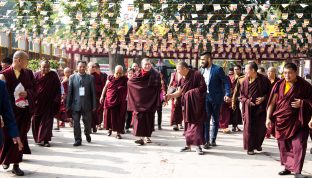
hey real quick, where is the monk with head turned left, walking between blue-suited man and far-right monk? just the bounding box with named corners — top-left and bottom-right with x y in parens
top-left (240, 62), bottom-right (271, 155)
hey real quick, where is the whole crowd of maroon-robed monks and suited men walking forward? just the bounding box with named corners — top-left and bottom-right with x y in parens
top-left (0, 51), bottom-right (312, 177)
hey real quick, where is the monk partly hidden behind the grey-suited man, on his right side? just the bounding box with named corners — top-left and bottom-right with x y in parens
top-left (88, 62), bottom-right (107, 133)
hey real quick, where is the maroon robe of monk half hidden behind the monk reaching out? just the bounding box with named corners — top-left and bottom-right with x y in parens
top-left (170, 72), bottom-right (183, 125)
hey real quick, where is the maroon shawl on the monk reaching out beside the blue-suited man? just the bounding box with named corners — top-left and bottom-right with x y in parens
top-left (181, 70), bottom-right (207, 124)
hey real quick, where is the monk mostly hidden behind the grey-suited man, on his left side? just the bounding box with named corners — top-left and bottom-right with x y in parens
top-left (55, 67), bottom-right (72, 130)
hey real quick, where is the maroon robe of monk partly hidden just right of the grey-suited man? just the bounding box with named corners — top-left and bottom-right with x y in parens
top-left (92, 72), bottom-right (107, 129)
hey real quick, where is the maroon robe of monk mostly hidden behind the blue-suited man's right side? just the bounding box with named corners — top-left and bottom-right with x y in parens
top-left (219, 77), bottom-right (233, 129)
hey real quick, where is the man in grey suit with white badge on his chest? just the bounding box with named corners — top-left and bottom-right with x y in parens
top-left (66, 61), bottom-right (96, 146)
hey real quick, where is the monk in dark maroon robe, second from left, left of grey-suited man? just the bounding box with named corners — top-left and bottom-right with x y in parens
top-left (32, 61), bottom-right (61, 147)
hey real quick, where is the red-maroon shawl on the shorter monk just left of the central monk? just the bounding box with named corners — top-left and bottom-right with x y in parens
top-left (104, 75), bottom-right (128, 109)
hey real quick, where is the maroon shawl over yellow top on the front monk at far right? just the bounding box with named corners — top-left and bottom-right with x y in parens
top-left (268, 76), bottom-right (312, 140)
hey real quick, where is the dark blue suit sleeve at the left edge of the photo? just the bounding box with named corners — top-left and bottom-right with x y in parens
top-left (0, 82), bottom-right (19, 138)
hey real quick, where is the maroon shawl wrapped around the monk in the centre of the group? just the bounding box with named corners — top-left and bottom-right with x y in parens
top-left (128, 69), bottom-right (161, 112)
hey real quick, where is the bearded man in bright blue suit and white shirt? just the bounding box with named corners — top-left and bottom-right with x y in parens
top-left (200, 52), bottom-right (231, 149)
